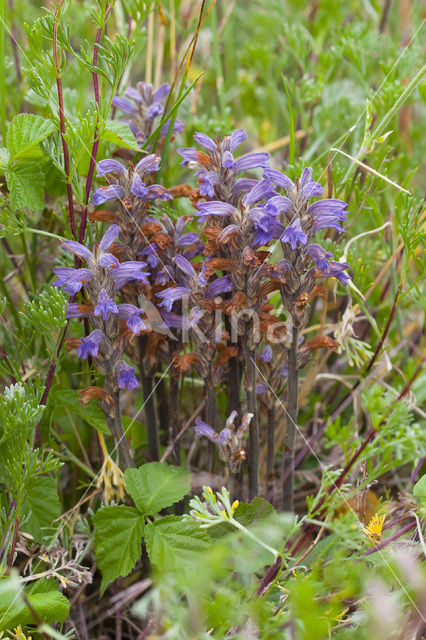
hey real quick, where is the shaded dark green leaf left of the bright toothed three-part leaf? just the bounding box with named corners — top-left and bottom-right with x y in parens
top-left (22, 476), bottom-right (61, 543)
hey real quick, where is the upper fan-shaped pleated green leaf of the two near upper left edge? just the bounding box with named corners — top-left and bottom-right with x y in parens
top-left (6, 113), bottom-right (56, 159)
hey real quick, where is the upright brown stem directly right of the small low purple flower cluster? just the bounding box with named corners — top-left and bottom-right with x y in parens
top-left (242, 330), bottom-right (259, 500)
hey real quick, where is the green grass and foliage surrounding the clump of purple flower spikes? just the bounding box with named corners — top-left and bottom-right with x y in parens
top-left (0, 0), bottom-right (426, 640)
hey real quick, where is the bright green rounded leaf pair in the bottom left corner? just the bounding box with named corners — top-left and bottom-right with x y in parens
top-left (0, 580), bottom-right (70, 632)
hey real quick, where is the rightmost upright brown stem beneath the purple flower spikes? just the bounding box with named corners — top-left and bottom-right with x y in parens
top-left (283, 325), bottom-right (299, 511)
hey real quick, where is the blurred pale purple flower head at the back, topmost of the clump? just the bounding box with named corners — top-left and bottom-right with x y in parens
top-left (112, 82), bottom-right (184, 145)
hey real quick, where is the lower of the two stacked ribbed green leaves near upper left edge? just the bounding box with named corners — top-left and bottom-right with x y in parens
top-left (6, 161), bottom-right (44, 211)
